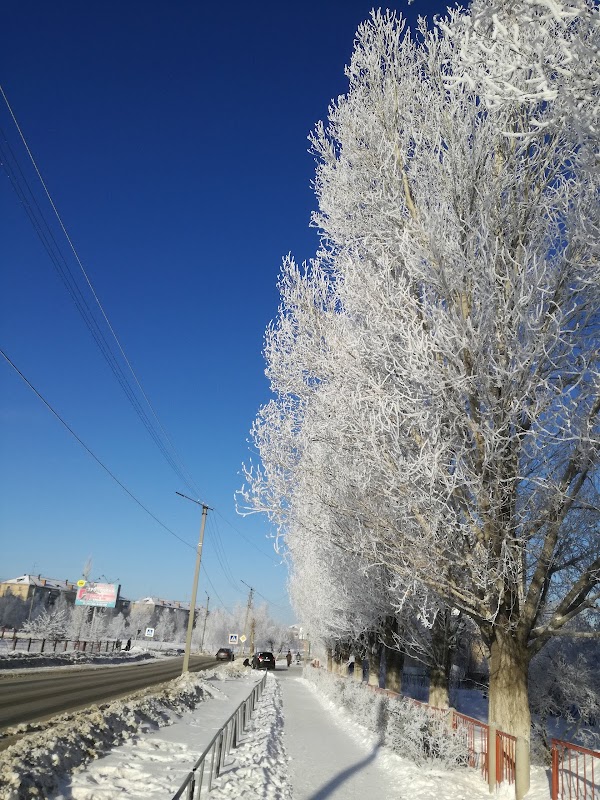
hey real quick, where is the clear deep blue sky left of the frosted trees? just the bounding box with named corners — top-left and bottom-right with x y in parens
top-left (0, 0), bottom-right (445, 623)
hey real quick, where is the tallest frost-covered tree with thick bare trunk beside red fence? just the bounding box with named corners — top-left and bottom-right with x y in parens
top-left (242, 2), bottom-right (600, 776)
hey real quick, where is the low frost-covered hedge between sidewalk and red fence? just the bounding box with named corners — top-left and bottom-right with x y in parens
top-left (304, 667), bottom-right (468, 769)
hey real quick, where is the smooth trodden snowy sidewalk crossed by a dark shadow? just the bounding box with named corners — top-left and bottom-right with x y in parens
top-left (277, 670), bottom-right (407, 800)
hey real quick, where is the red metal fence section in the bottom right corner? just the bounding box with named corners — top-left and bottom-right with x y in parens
top-left (552, 739), bottom-right (600, 800)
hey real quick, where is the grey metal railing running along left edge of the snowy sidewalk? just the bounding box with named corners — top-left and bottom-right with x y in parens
top-left (172, 670), bottom-right (267, 800)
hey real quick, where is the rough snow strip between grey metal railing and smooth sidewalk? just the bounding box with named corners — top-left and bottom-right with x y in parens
top-left (210, 674), bottom-right (292, 800)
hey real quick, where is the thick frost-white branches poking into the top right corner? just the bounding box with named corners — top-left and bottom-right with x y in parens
top-left (448, 0), bottom-right (600, 142)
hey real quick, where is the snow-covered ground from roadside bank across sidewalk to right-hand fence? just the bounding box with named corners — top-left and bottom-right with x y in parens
top-left (0, 665), bottom-right (550, 800)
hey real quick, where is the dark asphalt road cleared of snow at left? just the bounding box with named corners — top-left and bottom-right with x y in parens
top-left (0, 656), bottom-right (218, 729)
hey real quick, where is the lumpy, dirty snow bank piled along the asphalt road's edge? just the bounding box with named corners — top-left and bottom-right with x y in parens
top-left (0, 673), bottom-right (222, 800)
